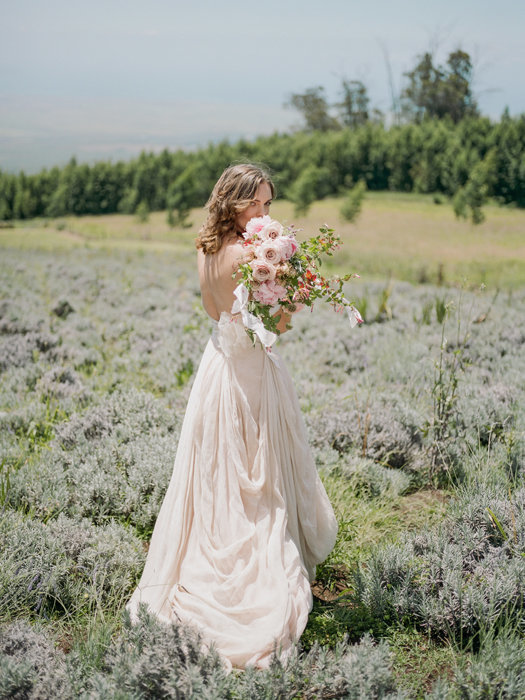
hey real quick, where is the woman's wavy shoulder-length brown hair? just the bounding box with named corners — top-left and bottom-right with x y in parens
top-left (195, 163), bottom-right (275, 253)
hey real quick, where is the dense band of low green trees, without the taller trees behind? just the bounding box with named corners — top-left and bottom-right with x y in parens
top-left (0, 114), bottom-right (525, 222)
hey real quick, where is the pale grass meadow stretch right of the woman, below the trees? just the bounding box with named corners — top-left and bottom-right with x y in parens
top-left (311, 193), bottom-right (525, 288)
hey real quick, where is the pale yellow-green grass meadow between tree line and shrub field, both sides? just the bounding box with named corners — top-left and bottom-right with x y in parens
top-left (0, 192), bottom-right (525, 289)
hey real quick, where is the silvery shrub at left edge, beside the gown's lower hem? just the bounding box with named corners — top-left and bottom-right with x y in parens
top-left (0, 509), bottom-right (144, 618)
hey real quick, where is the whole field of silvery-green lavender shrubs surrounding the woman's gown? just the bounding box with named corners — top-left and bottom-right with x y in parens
top-left (0, 216), bottom-right (525, 699)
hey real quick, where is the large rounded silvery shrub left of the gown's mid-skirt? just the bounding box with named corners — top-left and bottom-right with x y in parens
top-left (8, 388), bottom-right (179, 533)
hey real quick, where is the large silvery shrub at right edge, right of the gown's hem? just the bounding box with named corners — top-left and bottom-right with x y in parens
top-left (350, 488), bottom-right (525, 644)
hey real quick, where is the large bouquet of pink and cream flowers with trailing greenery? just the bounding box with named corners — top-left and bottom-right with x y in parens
top-left (232, 216), bottom-right (363, 348)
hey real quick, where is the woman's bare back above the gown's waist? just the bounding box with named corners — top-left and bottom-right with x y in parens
top-left (197, 238), bottom-right (243, 321)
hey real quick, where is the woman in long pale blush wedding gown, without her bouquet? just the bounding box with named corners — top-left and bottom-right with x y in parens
top-left (127, 165), bottom-right (337, 668)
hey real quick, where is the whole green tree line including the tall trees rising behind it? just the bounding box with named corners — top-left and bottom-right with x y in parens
top-left (0, 50), bottom-right (525, 225)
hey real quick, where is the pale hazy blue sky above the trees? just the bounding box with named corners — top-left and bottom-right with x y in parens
top-left (0, 0), bottom-right (525, 171)
